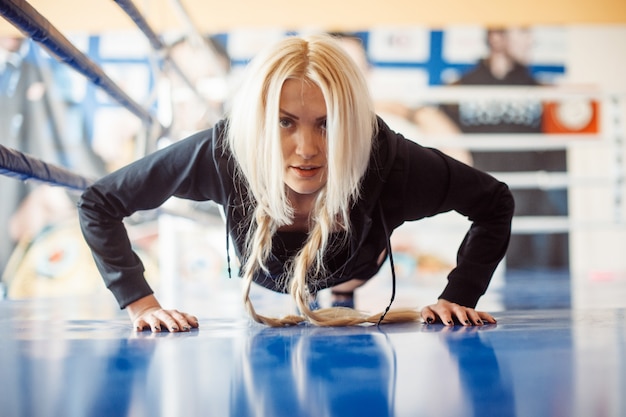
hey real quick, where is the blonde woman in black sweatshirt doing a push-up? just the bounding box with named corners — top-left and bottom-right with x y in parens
top-left (78, 36), bottom-right (514, 331)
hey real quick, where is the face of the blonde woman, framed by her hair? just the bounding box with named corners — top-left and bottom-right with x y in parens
top-left (279, 79), bottom-right (328, 202)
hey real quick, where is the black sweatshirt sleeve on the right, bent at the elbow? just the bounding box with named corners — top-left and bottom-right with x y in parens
top-left (398, 140), bottom-right (515, 308)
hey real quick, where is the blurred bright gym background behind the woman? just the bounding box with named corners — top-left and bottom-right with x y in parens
top-left (0, 0), bottom-right (626, 311)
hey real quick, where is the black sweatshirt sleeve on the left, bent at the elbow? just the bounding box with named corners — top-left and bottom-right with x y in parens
top-left (78, 128), bottom-right (230, 308)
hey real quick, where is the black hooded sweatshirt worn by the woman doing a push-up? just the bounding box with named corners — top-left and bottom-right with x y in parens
top-left (78, 119), bottom-right (514, 308)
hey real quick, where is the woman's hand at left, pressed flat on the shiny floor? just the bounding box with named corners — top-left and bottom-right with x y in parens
top-left (126, 295), bottom-right (198, 332)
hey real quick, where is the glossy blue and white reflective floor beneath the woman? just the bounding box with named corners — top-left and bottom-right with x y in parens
top-left (0, 299), bottom-right (626, 417)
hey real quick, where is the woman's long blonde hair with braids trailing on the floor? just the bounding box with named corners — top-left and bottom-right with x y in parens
top-left (227, 35), bottom-right (415, 326)
